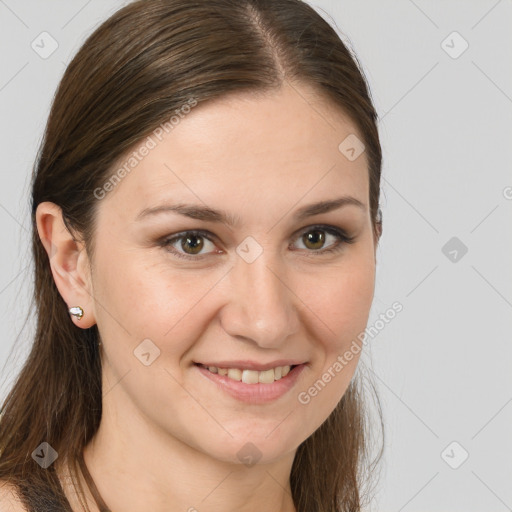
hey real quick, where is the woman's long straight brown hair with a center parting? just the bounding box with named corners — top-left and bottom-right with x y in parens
top-left (0, 0), bottom-right (384, 512)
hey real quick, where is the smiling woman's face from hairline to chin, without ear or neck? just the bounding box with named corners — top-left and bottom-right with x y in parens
top-left (87, 82), bottom-right (375, 463)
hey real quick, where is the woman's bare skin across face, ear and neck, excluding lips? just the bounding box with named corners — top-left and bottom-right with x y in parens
top-left (37, 84), bottom-right (376, 512)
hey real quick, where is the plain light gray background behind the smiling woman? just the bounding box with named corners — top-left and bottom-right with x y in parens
top-left (0, 0), bottom-right (512, 512)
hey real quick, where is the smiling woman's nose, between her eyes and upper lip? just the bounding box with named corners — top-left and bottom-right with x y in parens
top-left (220, 251), bottom-right (300, 348)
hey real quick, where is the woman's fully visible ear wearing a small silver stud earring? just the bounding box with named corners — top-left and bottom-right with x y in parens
top-left (36, 201), bottom-right (96, 329)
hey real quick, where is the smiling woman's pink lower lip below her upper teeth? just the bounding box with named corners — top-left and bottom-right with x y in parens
top-left (195, 364), bottom-right (306, 404)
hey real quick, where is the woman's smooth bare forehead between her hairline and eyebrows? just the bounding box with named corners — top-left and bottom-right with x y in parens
top-left (100, 83), bottom-right (368, 219)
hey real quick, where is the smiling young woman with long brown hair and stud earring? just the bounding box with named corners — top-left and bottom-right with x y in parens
top-left (0, 0), bottom-right (382, 512)
